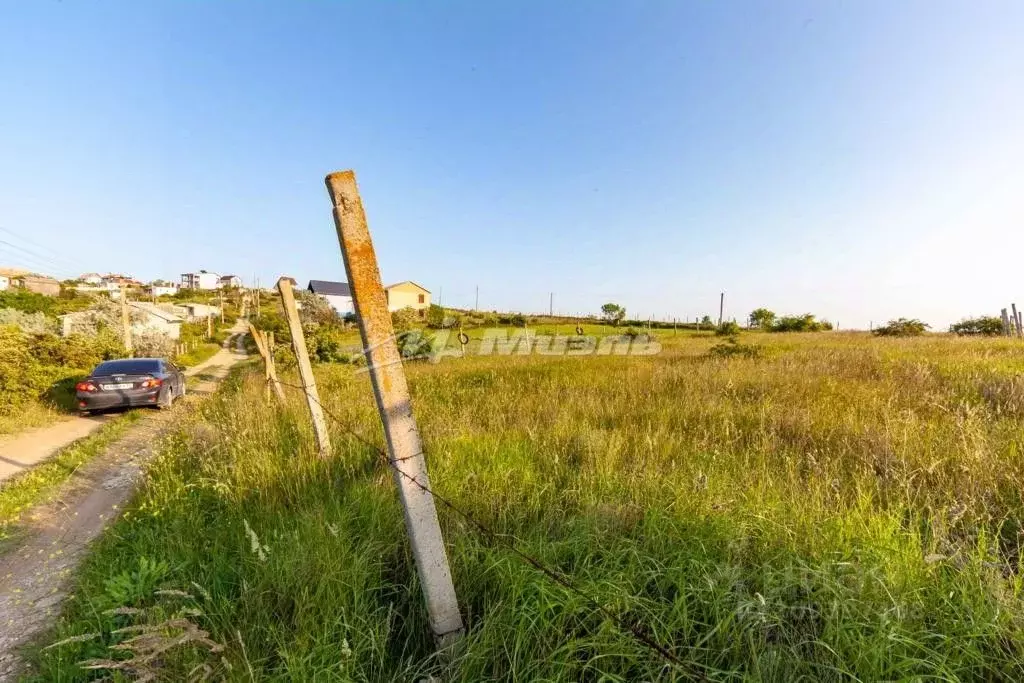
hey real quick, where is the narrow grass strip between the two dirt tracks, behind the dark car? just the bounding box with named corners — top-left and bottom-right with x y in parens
top-left (0, 411), bottom-right (141, 547)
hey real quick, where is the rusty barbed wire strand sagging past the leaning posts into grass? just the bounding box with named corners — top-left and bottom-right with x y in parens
top-left (267, 379), bottom-right (685, 667)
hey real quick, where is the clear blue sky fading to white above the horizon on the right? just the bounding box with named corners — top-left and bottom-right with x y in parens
top-left (0, 0), bottom-right (1024, 328)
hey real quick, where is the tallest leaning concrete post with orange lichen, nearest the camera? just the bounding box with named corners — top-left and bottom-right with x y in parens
top-left (327, 171), bottom-right (463, 648)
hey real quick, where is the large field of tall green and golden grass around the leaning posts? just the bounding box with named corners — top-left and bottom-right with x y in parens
top-left (24, 332), bottom-right (1024, 682)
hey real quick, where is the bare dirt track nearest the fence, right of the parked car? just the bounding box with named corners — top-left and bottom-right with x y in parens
top-left (0, 326), bottom-right (247, 682)
